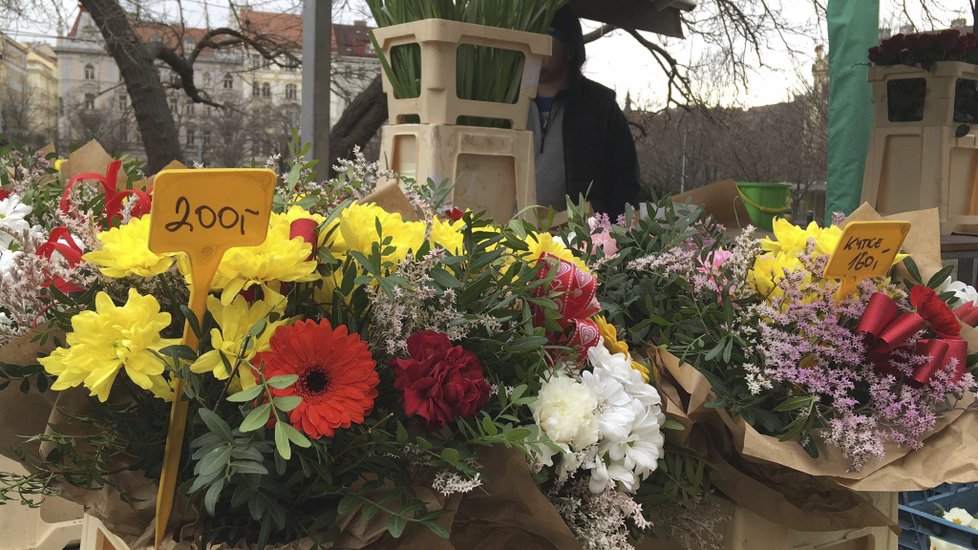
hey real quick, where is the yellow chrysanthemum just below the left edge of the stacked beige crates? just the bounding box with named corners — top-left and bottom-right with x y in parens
top-left (339, 204), bottom-right (425, 263)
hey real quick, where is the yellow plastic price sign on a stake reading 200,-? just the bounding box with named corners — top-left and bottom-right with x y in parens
top-left (149, 169), bottom-right (275, 548)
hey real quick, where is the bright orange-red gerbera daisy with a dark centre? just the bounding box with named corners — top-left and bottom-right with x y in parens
top-left (255, 319), bottom-right (380, 438)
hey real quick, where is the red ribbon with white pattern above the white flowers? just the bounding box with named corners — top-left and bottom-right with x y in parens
top-left (534, 253), bottom-right (601, 355)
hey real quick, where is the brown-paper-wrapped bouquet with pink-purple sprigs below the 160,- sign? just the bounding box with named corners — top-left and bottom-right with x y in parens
top-left (552, 201), bottom-right (978, 531)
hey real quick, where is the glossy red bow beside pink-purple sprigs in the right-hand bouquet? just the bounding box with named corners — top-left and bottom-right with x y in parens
top-left (856, 292), bottom-right (968, 384)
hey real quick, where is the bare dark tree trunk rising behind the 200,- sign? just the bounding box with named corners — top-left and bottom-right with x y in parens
top-left (81, 0), bottom-right (183, 173)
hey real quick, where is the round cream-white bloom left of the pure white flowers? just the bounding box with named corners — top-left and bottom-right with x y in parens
top-left (530, 374), bottom-right (599, 466)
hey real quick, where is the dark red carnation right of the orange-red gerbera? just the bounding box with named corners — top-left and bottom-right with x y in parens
top-left (391, 330), bottom-right (489, 429)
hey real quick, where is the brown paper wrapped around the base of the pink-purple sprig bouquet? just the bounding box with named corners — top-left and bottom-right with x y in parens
top-left (653, 332), bottom-right (978, 531)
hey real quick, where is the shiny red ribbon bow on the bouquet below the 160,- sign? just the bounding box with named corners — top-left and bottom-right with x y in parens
top-left (856, 292), bottom-right (968, 384)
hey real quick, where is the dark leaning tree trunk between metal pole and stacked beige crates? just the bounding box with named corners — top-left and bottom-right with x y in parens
top-left (328, 75), bottom-right (387, 174)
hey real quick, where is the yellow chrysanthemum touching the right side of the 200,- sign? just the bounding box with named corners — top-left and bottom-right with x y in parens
top-left (211, 214), bottom-right (318, 305)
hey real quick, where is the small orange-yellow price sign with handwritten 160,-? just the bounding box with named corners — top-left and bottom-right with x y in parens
top-left (825, 221), bottom-right (910, 300)
